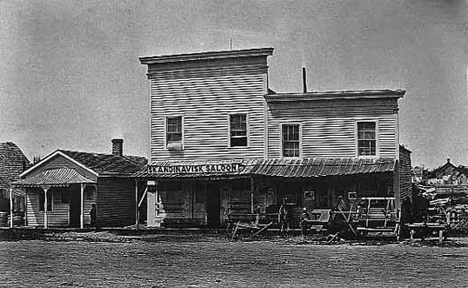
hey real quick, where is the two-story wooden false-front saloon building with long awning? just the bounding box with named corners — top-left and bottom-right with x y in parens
top-left (133, 48), bottom-right (411, 227)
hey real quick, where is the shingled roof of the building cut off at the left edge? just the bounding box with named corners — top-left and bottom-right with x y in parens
top-left (0, 142), bottom-right (31, 189)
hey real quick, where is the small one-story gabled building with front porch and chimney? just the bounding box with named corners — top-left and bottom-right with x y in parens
top-left (14, 139), bottom-right (147, 228)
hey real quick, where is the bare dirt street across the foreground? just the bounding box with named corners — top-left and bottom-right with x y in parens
top-left (0, 233), bottom-right (468, 287)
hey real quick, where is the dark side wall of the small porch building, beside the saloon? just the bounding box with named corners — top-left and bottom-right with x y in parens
top-left (96, 178), bottom-right (135, 227)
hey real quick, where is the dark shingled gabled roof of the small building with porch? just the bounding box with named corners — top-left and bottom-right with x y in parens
top-left (21, 149), bottom-right (147, 177)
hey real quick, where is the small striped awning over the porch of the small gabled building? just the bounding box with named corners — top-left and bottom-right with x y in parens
top-left (13, 168), bottom-right (96, 187)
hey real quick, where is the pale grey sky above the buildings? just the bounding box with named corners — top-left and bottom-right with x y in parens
top-left (0, 0), bottom-right (468, 168)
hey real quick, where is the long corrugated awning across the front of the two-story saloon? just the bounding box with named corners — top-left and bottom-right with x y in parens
top-left (132, 158), bottom-right (396, 178)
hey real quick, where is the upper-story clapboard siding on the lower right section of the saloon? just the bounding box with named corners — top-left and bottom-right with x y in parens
top-left (267, 99), bottom-right (398, 158)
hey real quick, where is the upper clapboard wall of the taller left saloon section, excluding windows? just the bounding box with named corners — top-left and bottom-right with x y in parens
top-left (151, 71), bottom-right (266, 161)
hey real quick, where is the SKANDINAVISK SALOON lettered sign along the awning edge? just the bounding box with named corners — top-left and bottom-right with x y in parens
top-left (148, 163), bottom-right (244, 174)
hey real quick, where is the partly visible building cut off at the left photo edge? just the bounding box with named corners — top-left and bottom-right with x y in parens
top-left (0, 142), bottom-right (30, 225)
